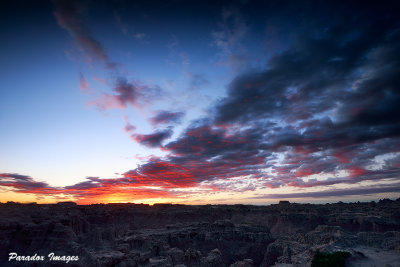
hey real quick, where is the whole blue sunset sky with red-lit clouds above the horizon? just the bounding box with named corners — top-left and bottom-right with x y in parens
top-left (0, 0), bottom-right (400, 205)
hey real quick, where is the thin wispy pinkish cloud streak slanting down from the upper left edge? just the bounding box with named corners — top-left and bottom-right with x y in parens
top-left (54, 0), bottom-right (162, 110)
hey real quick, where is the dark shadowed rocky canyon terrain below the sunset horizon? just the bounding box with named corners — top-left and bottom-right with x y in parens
top-left (0, 199), bottom-right (400, 267)
